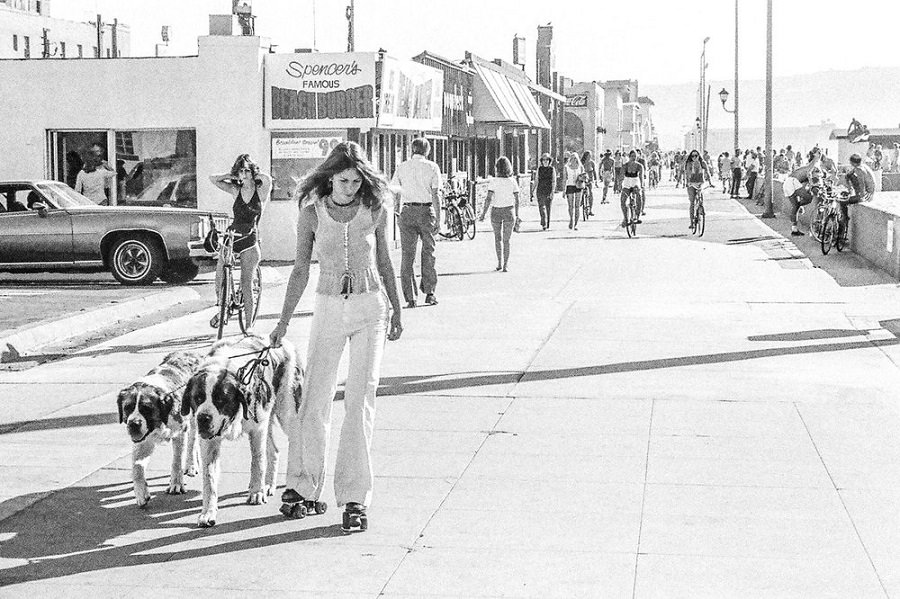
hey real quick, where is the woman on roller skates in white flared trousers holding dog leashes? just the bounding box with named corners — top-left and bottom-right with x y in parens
top-left (270, 142), bottom-right (403, 531)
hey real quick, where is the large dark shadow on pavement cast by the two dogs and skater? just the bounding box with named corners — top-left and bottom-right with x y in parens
top-left (0, 478), bottom-right (344, 587)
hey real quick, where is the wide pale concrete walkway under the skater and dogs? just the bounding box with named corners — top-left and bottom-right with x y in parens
top-left (0, 187), bottom-right (900, 598)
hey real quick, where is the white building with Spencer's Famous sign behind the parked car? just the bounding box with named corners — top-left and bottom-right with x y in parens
top-left (0, 17), bottom-right (443, 260)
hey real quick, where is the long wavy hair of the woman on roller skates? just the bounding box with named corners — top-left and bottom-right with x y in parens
top-left (294, 141), bottom-right (389, 212)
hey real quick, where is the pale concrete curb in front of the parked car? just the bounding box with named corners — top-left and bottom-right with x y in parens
top-left (0, 287), bottom-right (200, 363)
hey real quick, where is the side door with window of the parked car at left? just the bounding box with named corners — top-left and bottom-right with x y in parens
top-left (0, 184), bottom-right (73, 266)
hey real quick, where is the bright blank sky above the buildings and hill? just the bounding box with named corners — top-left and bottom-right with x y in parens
top-left (51, 0), bottom-right (900, 84)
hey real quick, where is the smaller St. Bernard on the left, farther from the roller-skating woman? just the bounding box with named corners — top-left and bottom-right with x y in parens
top-left (116, 351), bottom-right (202, 507)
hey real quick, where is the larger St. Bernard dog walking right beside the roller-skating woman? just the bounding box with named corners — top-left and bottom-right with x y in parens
top-left (181, 335), bottom-right (303, 527)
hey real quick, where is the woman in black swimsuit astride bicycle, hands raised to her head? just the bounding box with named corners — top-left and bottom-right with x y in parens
top-left (209, 154), bottom-right (272, 329)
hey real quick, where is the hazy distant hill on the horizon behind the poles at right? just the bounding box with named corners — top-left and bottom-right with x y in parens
top-left (640, 67), bottom-right (900, 148)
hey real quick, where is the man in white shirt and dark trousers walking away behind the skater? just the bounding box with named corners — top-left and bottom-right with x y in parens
top-left (391, 137), bottom-right (441, 308)
